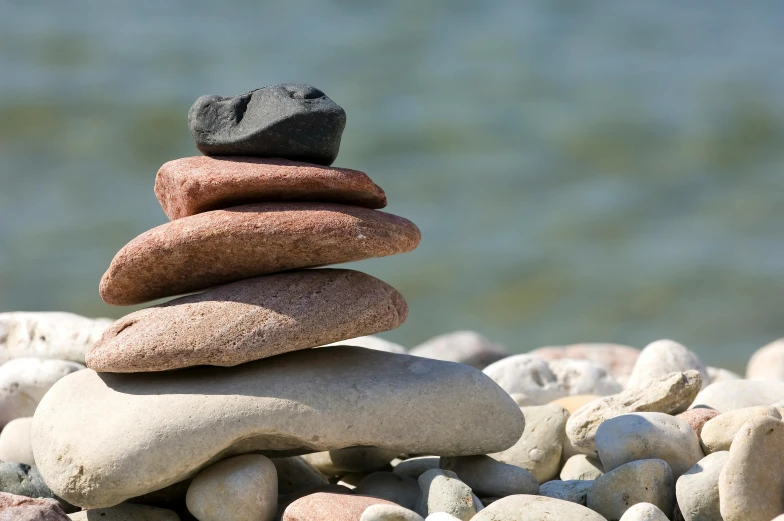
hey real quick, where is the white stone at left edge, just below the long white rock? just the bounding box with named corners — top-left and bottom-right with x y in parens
top-left (0, 358), bottom-right (84, 429)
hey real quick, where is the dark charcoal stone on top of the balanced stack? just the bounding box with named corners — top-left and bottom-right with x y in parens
top-left (188, 83), bottom-right (346, 165)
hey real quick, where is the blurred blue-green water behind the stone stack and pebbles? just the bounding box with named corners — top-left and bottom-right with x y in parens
top-left (0, 0), bottom-right (784, 370)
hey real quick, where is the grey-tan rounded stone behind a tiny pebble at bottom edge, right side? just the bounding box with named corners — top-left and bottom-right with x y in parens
top-left (588, 460), bottom-right (672, 521)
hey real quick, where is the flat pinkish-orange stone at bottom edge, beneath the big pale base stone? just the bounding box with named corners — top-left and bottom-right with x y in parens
top-left (283, 492), bottom-right (397, 521)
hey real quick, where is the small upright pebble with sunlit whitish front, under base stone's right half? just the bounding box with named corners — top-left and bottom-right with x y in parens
top-left (414, 469), bottom-right (477, 521)
